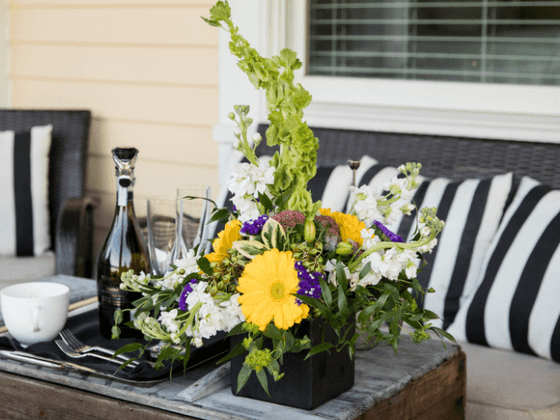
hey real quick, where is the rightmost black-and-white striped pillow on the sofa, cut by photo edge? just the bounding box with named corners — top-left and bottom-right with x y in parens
top-left (449, 177), bottom-right (560, 362)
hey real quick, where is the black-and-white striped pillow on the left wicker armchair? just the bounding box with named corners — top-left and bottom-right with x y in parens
top-left (0, 125), bottom-right (52, 256)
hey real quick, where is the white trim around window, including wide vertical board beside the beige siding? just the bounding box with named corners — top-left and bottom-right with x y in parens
top-left (214, 0), bottom-right (560, 183)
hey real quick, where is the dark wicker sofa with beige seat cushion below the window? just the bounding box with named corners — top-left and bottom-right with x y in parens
top-left (217, 125), bottom-right (560, 420)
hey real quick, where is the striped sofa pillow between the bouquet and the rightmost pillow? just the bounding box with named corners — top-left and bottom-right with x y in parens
top-left (391, 173), bottom-right (513, 329)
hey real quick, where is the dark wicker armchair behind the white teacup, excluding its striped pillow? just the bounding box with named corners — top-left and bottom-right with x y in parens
top-left (0, 109), bottom-right (94, 288)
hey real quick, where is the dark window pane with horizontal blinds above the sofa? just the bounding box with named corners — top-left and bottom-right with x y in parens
top-left (308, 0), bottom-right (560, 85)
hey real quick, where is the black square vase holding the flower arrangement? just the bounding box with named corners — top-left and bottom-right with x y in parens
top-left (231, 318), bottom-right (355, 410)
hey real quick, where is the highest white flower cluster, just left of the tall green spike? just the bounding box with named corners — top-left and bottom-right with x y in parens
top-left (227, 161), bottom-right (276, 223)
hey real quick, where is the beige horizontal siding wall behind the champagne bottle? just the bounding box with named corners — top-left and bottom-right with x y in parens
top-left (9, 0), bottom-right (219, 262)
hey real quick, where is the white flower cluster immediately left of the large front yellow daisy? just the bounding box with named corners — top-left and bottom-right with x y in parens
top-left (186, 281), bottom-right (245, 347)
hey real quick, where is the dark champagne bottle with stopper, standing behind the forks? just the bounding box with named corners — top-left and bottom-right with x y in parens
top-left (95, 148), bottom-right (150, 339)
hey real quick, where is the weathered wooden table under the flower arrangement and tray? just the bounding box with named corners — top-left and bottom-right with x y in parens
top-left (0, 280), bottom-right (466, 420)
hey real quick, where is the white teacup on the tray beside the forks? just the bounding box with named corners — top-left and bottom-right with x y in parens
top-left (0, 282), bottom-right (70, 345)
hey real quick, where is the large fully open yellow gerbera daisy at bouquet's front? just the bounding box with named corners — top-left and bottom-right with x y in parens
top-left (237, 249), bottom-right (309, 331)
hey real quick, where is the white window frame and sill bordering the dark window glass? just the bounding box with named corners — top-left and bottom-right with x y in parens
top-left (282, 0), bottom-right (560, 143)
